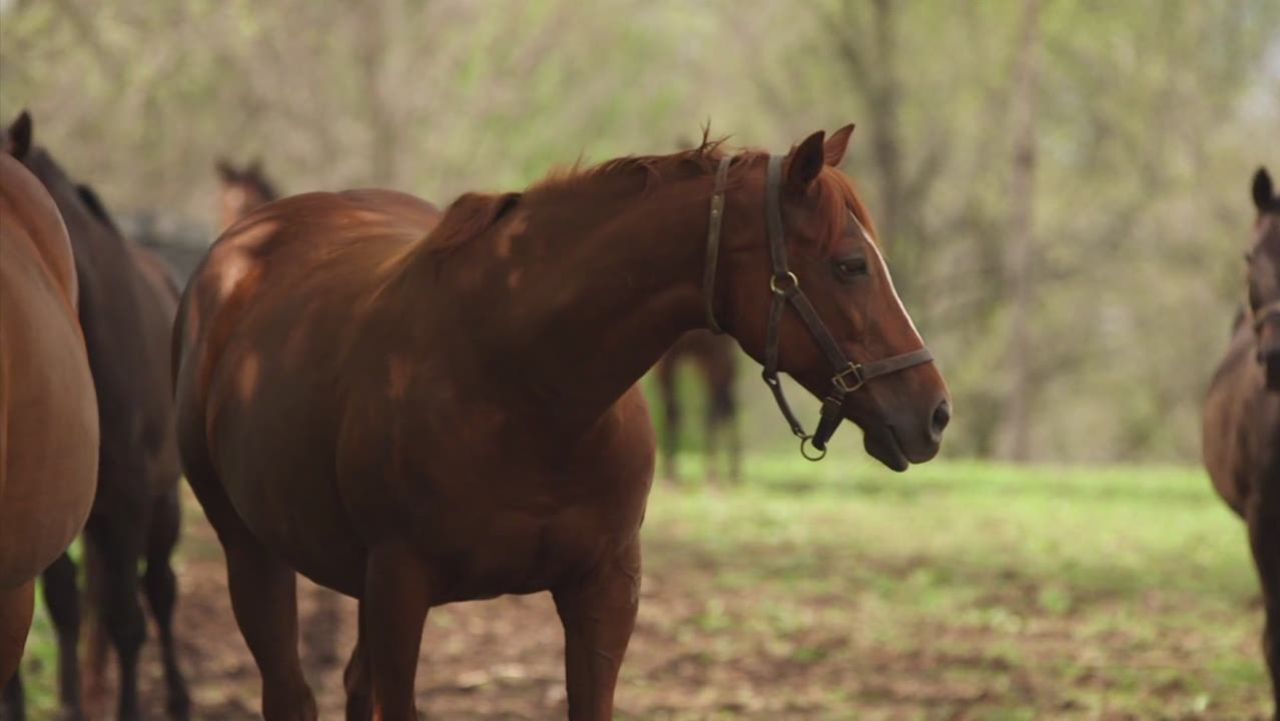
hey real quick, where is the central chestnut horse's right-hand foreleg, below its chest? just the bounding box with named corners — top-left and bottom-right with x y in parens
top-left (552, 539), bottom-right (640, 721)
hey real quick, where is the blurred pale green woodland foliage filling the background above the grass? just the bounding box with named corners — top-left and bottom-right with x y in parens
top-left (0, 0), bottom-right (1280, 460)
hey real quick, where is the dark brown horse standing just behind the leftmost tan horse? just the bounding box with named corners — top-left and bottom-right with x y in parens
top-left (5, 113), bottom-right (189, 721)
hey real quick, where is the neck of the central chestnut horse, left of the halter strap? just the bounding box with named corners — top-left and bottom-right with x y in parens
top-left (430, 178), bottom-right (710, 428)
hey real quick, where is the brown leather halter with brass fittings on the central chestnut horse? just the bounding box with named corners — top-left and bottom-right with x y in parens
top-left (703, 155), bottom-right (936, 461)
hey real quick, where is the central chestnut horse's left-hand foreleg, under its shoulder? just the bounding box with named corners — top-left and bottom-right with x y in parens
top-left (357, 546), bottom-right (431, 721)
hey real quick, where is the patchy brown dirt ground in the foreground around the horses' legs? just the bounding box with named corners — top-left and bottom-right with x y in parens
top-left (28, 473), bottom-right (1265, 721)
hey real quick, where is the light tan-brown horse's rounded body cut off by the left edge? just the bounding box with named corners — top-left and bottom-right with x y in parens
top-left (0, 149), bottom-right (99, 716)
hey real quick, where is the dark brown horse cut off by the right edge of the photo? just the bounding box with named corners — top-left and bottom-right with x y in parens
top-left (1204, 169), bottom-right (1280, 717)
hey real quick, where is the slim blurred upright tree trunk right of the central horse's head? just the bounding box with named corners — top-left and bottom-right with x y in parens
top-left (1005, 0), bottom-right (1039, 461)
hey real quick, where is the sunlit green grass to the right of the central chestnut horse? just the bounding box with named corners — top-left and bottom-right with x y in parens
top-left (645, 455), bottom-right (1268, 720)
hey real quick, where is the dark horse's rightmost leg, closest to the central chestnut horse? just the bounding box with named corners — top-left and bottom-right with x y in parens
top-left (142, 488), bottom-right (191, 721)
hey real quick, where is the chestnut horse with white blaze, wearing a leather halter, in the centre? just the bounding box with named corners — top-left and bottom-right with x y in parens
top-left (174, 126), bottom-right (950, 721)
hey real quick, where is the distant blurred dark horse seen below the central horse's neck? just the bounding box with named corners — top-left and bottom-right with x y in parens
top-left (654, 329), bottom-right (742, 480)
